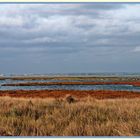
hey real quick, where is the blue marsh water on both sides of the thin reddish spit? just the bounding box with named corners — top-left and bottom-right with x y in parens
top-left (0, 77), bottom-right (140, 91)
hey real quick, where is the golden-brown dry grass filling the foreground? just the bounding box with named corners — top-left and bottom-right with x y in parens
top-left (0, 97), bottom-right (140, 136)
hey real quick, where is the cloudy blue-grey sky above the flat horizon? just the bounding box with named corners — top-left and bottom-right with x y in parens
top-left (0, 3), bottom-right (140, 74)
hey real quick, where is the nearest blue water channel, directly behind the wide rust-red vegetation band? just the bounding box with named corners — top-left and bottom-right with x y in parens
top-left (0, 85), bottom-right (140, 91)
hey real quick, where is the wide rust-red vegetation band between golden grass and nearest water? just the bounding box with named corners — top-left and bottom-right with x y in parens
top-left (0, 90), bottom-right (140, 99)
